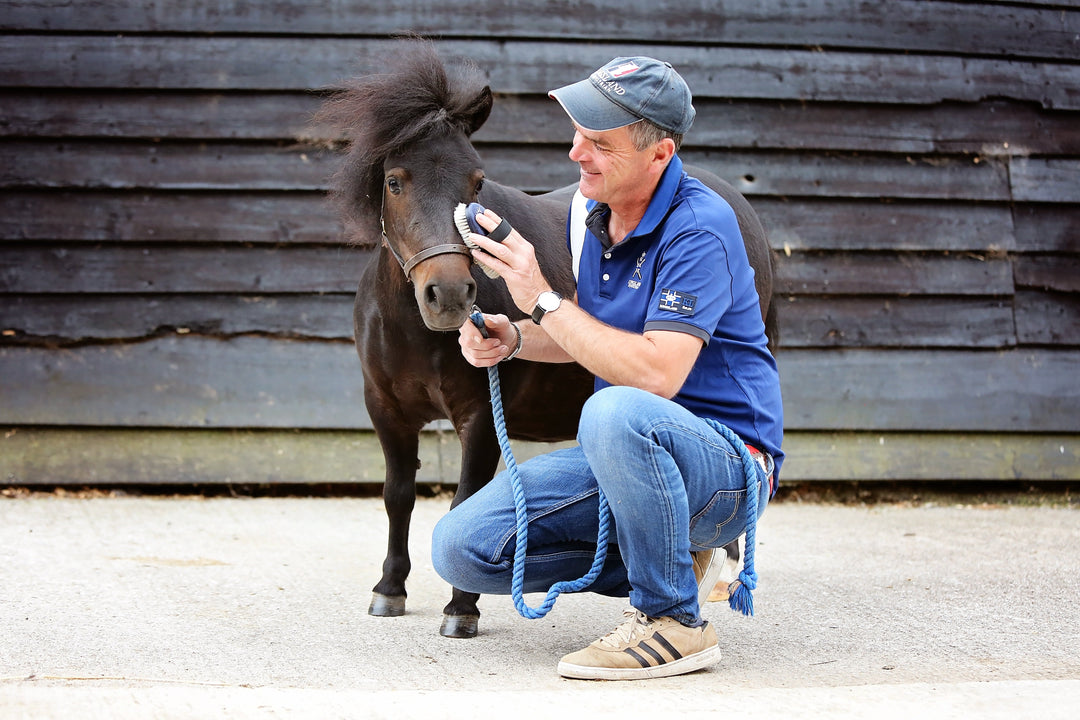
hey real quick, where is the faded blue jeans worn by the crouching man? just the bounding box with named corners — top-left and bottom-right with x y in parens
top-left (432, 386), bottom-right (769, 624)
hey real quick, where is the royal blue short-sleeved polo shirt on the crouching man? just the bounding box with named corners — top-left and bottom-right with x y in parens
top-left (578, 155), bottom-right (784, 478)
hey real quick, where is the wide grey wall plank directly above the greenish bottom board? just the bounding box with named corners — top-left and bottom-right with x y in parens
top-left (0, 335), bottom-right (1080, 433)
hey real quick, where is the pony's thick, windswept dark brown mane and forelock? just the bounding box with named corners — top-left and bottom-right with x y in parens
top-left (315, 40), bottom-right (486, 237)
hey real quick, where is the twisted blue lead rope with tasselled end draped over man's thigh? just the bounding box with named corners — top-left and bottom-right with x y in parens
top-left (469, 307), bottom-right (768, 620)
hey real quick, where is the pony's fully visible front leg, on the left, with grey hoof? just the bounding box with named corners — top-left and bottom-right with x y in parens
top-left (367, 427), bottom-right (420, 617)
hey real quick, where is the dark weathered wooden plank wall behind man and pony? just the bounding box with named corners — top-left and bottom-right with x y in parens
top-left (0, 0), bottom-right (1080, 484)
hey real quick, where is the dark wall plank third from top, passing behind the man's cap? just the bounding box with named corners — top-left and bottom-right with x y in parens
top-left (8, 90), bottom-right (1080, 157)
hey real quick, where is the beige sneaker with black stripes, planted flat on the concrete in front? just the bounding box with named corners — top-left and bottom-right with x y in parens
top-left (558, 608), bottom-right (720, 680)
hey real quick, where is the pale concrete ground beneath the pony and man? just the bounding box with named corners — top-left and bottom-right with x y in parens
top-left (0, 493), bottom-right (1080, 720)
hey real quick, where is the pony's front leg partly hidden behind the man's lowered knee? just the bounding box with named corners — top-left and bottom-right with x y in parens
top-left (438, 417), bottom-right (499, 638)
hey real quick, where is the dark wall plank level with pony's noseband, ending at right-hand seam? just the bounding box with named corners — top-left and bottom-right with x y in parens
top-left (0, 244), bottom-right (1010, 296)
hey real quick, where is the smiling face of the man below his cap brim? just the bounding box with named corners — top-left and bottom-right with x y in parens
top-left (570, 123), bottom-right (652, 205)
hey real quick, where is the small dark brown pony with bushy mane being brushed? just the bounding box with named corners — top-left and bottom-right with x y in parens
top-left (316, 40), bottom-right (774, 637)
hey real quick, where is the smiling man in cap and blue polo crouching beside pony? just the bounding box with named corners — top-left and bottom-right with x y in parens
top-left (432, 57), bottom-right (783, 679)
